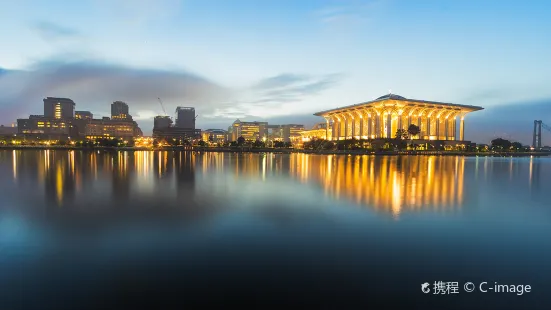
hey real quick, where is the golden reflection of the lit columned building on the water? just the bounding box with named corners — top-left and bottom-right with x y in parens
top-left (290, 154), bottom-right (465, 216)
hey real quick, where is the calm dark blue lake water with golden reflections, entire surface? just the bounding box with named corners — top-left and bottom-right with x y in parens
top-left (0, 150), bottom-right (551, 309)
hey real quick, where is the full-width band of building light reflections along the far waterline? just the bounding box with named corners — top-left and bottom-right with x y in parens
top-left (1, 150), bottom-right (542, 217)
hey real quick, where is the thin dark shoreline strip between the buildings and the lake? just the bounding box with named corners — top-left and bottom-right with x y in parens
top-left (0, 145), bottom-right (551, 157)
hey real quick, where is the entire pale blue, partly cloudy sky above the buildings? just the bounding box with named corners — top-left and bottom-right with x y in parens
top-left (0, 0), bottom-right (551, 145)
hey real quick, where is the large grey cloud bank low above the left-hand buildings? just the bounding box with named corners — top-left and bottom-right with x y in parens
top-left (0, 60), bottom-right (231, 131)
